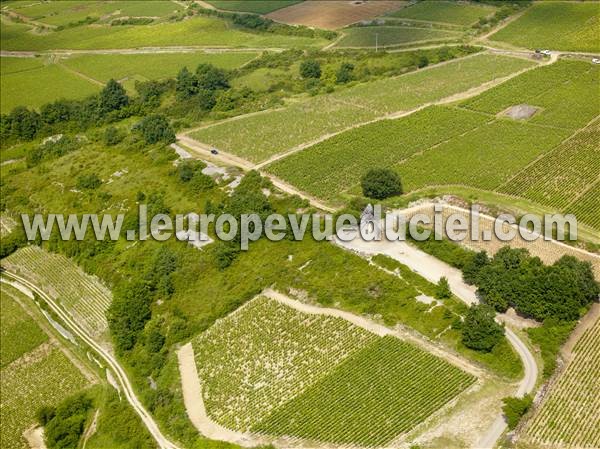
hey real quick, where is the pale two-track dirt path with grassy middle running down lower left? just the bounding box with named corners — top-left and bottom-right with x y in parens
top-left (2, 271), bottom-right (180, 449)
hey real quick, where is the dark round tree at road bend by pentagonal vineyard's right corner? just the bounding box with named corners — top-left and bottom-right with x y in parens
top-left (462, 304), bottom-right (504, 352)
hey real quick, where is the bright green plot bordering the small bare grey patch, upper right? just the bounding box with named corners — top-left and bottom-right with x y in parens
top-left (461, 60), bottom-right (600, 130)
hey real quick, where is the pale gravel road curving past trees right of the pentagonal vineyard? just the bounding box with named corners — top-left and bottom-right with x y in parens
top-left (336, 229), bottom-right (538, 449)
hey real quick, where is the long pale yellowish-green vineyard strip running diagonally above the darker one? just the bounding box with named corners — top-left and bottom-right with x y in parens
top-left (191, 55), bottom-right (532, 162)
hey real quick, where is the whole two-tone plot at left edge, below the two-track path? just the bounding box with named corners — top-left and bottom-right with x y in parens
top-left (0, 284), bottom-right (88, 449)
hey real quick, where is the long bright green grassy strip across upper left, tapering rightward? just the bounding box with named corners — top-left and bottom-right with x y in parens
top-left (1, 17), bottom-right (327, 51)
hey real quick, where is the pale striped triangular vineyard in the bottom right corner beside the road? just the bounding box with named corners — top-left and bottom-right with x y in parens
top-left (523, 320), bottom-right (600, 448)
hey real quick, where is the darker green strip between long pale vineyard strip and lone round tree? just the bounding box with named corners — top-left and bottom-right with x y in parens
top-left (267, 106), bottom-right (489, 200)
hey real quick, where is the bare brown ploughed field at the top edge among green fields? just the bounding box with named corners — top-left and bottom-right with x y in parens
top-left (267, 0), bottom-right (407, 30)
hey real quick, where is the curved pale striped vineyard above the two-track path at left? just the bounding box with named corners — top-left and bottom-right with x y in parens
top-left (2, 246), bottom-right (111, 336)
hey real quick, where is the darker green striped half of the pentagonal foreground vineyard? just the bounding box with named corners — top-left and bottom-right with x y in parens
top-left (254, 336), bottom-right (475, 446)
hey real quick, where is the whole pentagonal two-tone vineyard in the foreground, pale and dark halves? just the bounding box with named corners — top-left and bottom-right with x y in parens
top-left (193, 297), bottom-right (475, 446)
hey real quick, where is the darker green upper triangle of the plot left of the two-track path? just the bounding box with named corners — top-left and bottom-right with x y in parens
top-left (0, 283), bottom-right (48, 368)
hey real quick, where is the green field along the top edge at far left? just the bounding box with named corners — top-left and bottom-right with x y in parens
top-left (8, 0), bottom-right (183, 26)
